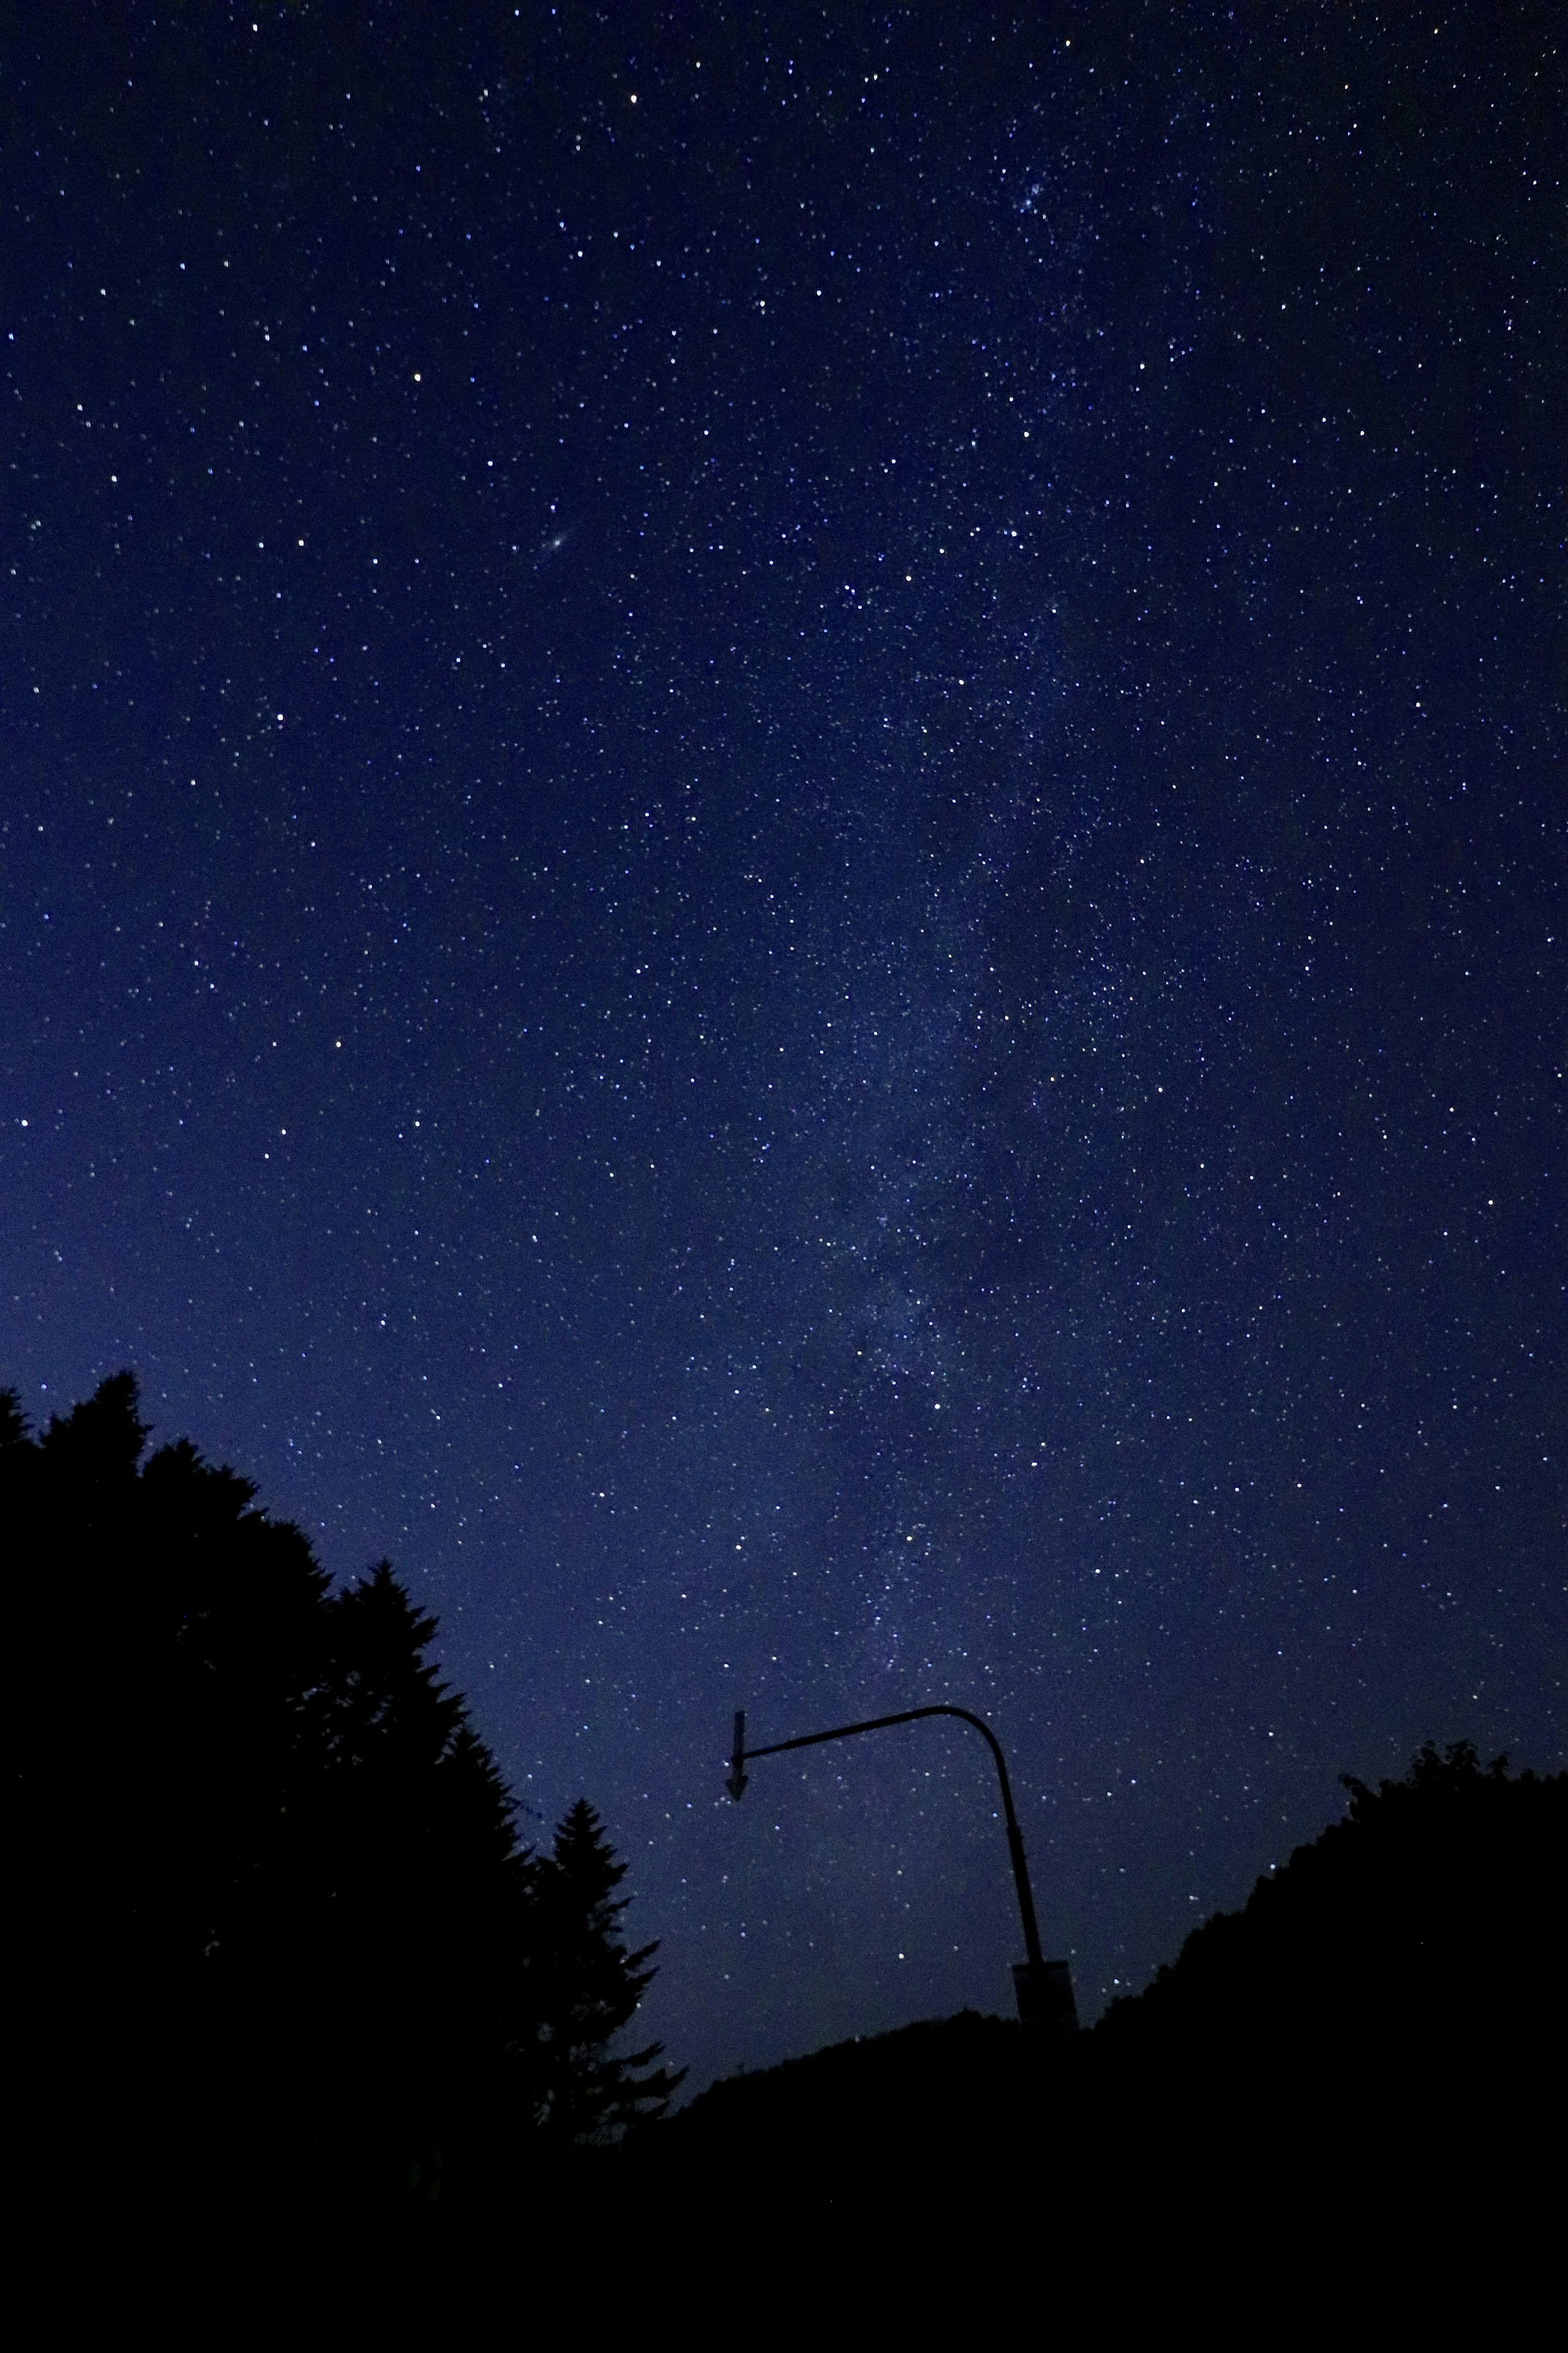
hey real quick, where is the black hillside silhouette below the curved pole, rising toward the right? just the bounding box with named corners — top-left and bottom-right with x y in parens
top-left (465, 1746), bottom-right (1568, 2334)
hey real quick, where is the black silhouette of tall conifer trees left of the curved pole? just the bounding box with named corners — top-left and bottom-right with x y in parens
top-left (0, 1374), bottom-right (677, 2210)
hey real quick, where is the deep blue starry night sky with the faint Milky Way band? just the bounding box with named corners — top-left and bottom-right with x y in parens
top-left (0, 0), bottom-right (1568, 2087)
